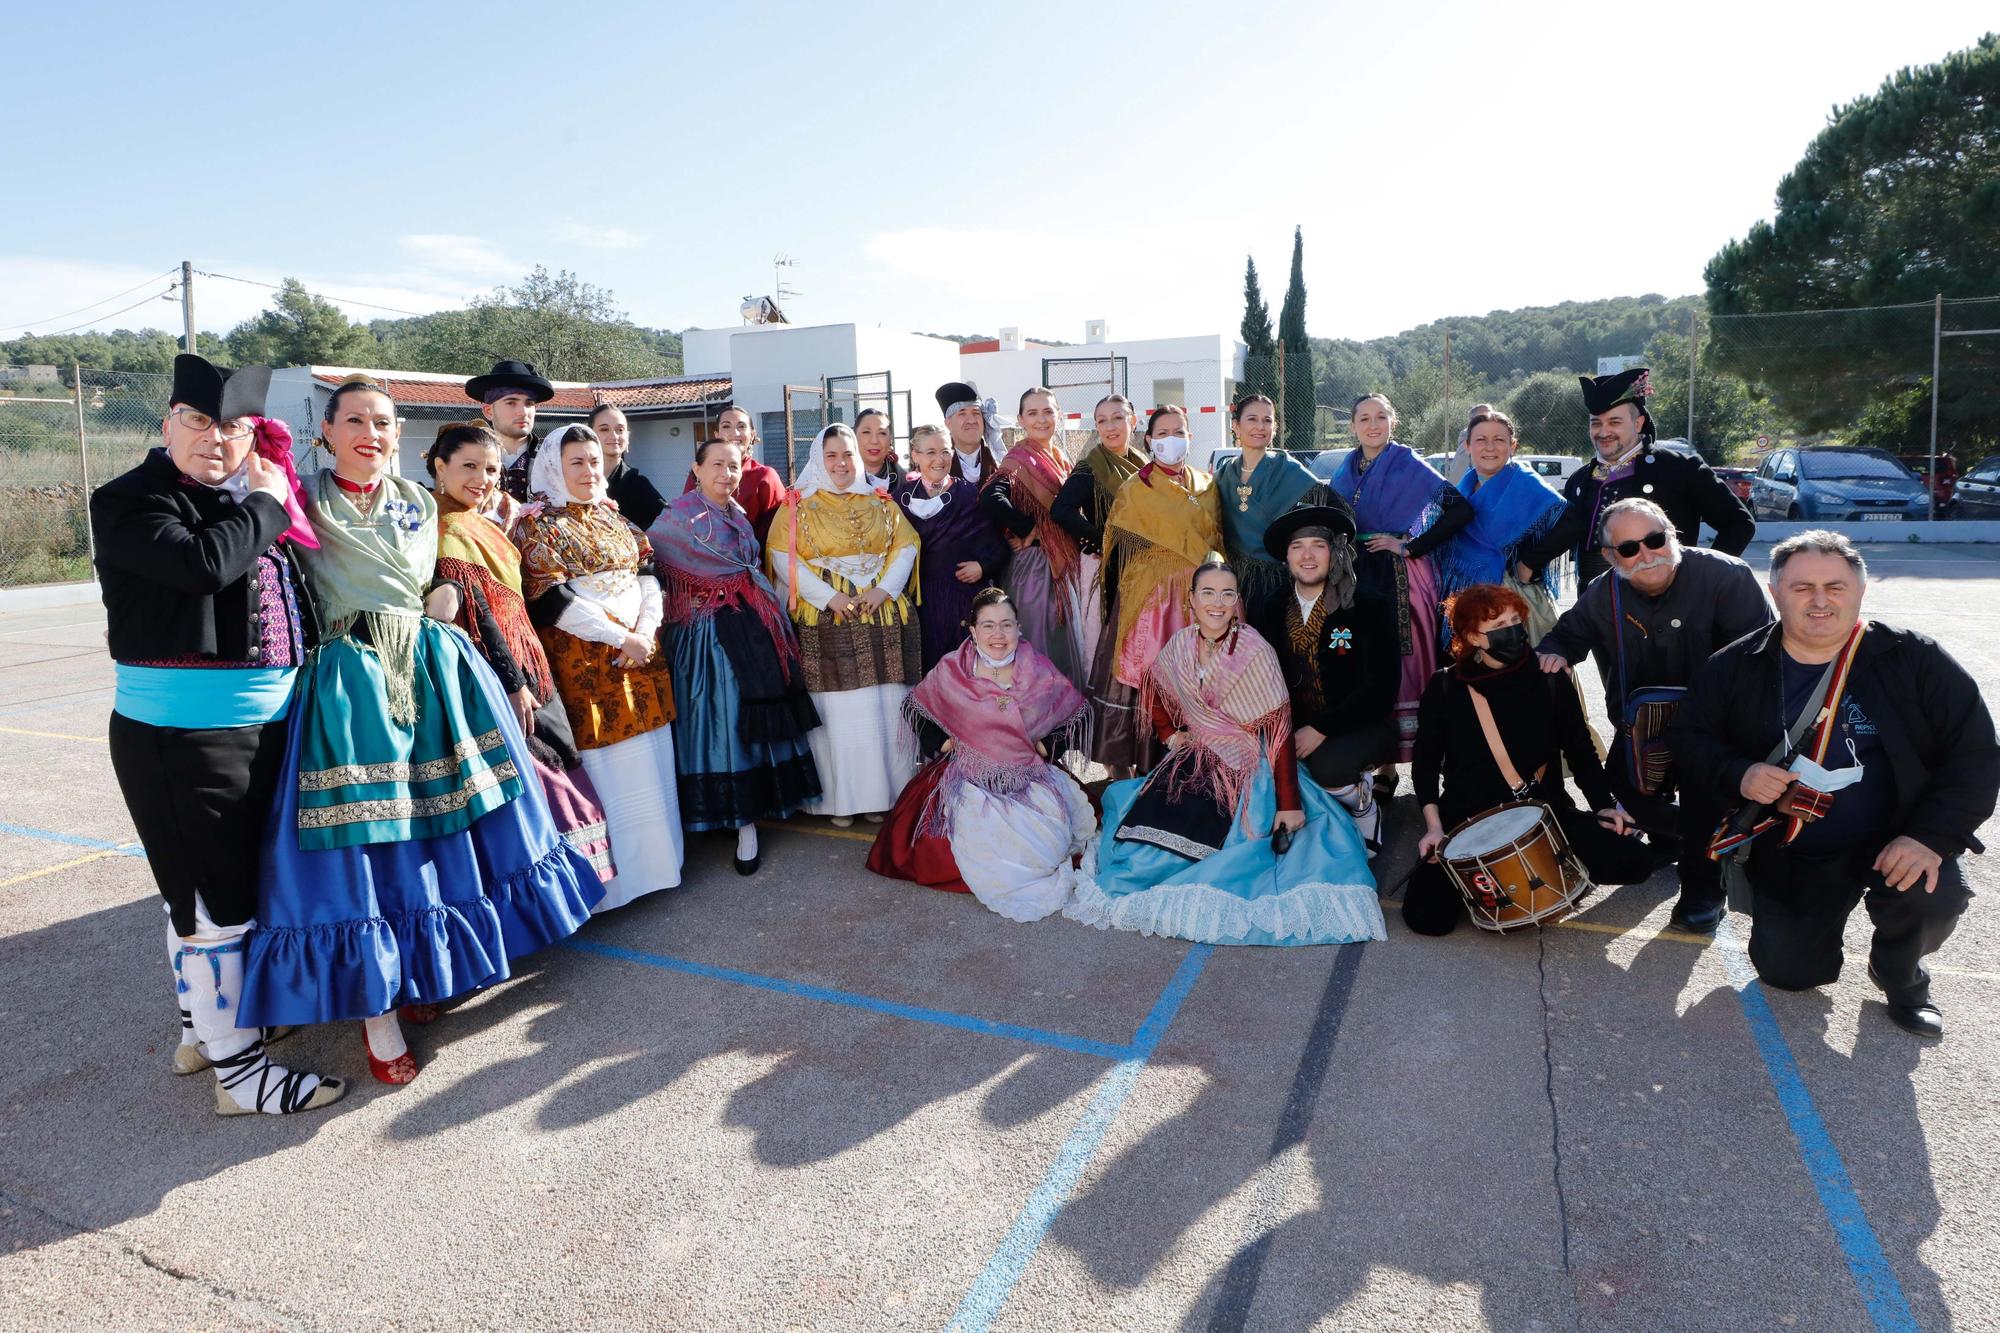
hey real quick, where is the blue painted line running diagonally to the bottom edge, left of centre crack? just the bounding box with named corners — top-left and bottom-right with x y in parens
top-left (946, 945), bottom-right (1214, 1333)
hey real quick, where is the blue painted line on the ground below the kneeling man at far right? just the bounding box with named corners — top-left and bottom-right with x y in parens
top-left (1716, 923), bottom-right (1918, 1333)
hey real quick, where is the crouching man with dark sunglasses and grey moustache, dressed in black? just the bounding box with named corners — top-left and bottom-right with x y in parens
top-left (1536, 498), bottom-right (1772, 935)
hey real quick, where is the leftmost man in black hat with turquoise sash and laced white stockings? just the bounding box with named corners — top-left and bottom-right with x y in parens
top-left (90, 354), bottom-right (344, 1115)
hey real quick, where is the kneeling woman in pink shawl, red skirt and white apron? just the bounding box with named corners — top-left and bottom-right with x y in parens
top-left (868, 588), bottom-right (1096, 921)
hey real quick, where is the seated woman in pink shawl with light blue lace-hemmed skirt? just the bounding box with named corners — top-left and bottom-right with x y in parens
top-left (1064, 556), bottom-right (1384, 945)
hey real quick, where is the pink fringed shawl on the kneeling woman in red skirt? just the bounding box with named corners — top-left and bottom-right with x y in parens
top-left (904, 638), bottom-right (1090, 837)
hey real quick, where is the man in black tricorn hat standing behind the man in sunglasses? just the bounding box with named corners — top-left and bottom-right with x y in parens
top-left (1514, 366), bottom-right (1756, 588)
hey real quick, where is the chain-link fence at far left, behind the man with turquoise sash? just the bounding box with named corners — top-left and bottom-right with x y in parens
top-left (0, 366), bottom-right (174, 588)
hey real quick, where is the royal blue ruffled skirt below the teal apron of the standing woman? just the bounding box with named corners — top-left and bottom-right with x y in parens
top-left (240, 620), bottom-right (604, 1027)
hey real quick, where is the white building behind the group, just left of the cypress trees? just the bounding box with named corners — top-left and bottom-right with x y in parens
top-left (958, 320), bottom-right (1248, 468)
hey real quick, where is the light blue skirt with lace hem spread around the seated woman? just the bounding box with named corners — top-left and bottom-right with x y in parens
top-left (1062, 761), bottom-right (1388, 945)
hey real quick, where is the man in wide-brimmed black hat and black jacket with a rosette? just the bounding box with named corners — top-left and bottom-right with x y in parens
top-left (1248, 504), bottom-right (1402, 855)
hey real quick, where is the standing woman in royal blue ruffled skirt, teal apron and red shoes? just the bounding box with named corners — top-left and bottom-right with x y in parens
top-left (242, 382), bottom-right (604, 1083)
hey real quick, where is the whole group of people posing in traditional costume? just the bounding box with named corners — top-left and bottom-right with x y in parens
top-left (90, 356), bottom-right (2000, 1115)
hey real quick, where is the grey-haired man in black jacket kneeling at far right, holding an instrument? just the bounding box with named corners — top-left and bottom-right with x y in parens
top-left (1668, 530), bottom-right (2000, 1037)
